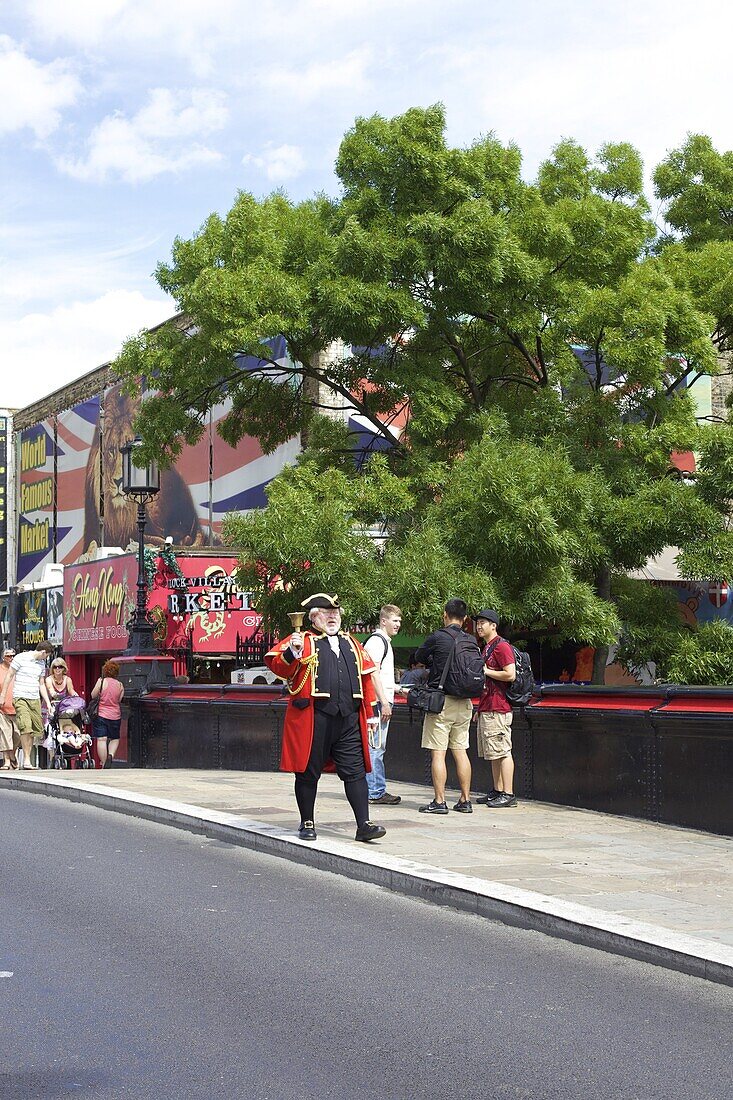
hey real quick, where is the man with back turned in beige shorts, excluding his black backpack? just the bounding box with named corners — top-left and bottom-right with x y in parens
top-left (415, 600), bottom-right (478, 814)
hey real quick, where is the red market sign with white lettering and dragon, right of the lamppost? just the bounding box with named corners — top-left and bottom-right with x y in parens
top-left (147, 554), bottom-right (262, 653)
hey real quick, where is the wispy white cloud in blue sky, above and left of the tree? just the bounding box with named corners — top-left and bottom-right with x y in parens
top-left (56, 88), bottom-right (228, 184)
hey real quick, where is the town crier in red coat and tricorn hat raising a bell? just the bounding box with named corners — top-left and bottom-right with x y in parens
top-left (265, 592), bottom-right (386, 840)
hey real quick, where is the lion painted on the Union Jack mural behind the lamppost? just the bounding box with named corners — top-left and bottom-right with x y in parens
top-left (84, 386), bottom-right (205, 552)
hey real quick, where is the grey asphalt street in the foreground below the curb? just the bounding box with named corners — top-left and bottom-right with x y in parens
top-left (0, 790), bottom-right (733, 1100)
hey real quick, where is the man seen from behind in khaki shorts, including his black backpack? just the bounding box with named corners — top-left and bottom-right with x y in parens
top-left (415, 600), bottom-right (483, 814)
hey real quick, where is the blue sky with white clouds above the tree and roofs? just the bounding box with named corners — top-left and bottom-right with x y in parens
top-left (0, 0), bottom-right (733, 408)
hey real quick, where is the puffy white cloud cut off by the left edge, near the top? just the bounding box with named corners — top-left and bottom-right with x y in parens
top-left (0, 35), bottom-right (81, 139)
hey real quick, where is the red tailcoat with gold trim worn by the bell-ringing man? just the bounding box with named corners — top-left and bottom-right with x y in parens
top-left (265, 630), bottom-right (376, 772)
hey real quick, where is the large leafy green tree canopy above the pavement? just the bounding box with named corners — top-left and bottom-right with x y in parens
top-left (118, 106), bottom-right (733, 677)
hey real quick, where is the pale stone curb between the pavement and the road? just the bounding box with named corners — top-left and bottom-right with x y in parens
top-left (0, 776), bottom-right (733, 986)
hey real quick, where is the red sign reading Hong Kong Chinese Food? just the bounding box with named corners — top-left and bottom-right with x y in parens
top-left (64, 554), bottom-right (138, 653)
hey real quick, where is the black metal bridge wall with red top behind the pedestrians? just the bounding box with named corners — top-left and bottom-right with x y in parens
top-left (130, 686), bottom-right (733, 836)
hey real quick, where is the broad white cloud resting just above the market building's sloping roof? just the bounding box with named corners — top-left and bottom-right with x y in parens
top-left (0, 290), bottom-right (175, 408)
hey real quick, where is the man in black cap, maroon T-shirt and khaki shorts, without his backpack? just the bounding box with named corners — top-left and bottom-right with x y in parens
top-left (473, 608), bottom-right (516, 810)
